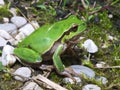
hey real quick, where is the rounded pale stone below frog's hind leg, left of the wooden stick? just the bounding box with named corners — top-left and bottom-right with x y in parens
top-left (14, 67), bottom-right (31, 81)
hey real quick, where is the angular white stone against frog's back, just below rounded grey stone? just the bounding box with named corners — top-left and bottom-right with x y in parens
top-left (19, 23), bottom-right (35, 36)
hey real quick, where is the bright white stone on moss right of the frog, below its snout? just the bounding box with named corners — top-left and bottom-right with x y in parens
top-left (83, 39), bottom-right (98, 53)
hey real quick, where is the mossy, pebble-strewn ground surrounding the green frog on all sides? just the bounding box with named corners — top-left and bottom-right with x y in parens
top-left (0, 0), bottom-right (120, 90)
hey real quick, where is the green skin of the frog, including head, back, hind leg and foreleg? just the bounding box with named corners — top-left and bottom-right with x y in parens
top-left (14, 15), bottom-right (86, 71)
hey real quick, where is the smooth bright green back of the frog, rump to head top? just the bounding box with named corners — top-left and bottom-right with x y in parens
top-left (19, 17), bottom-right (83, 54)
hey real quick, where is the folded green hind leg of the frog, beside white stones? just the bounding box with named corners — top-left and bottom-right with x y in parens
top-left (14, 48), bottom-right (42, 63)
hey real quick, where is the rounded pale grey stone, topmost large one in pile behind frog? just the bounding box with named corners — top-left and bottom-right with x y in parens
top-left (11, 16), bottom-right (27, 28)
